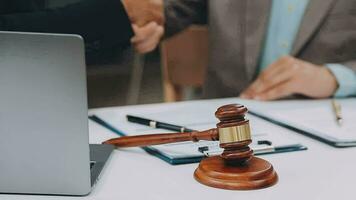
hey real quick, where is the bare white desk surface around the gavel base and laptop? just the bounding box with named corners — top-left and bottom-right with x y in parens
top-left (0, 99), bottom-right (356, 200)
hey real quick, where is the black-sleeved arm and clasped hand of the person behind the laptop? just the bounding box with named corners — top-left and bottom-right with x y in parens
top-left (0, 0), bottom-right (164, 61)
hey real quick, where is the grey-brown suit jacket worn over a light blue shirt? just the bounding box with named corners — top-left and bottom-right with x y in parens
top-left (165, 0), bottom-right (356, 98)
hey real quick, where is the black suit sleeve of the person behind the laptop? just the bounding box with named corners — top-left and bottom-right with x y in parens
top-left (0, 0), bottom-right (133, 50)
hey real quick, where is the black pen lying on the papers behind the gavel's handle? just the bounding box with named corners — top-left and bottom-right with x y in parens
top-left (126, 115), bottom-right (195, 133)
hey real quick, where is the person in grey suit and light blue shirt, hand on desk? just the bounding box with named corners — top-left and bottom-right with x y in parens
top-left (133, 0), bottom-right (356, 100)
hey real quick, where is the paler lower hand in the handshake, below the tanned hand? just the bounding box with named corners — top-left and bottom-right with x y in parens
top-left (131, 22), bottom-right (164, 53)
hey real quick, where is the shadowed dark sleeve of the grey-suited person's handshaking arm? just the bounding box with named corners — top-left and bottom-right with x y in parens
top-left (164, 0), bottom-right (208, 37)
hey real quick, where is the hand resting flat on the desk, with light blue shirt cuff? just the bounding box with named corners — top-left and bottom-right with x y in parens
top-left (240, 56), bottom-right (338, 101)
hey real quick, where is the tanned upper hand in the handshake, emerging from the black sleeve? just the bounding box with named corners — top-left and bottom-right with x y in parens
top-left (122, 0), bottom-right (164, 27)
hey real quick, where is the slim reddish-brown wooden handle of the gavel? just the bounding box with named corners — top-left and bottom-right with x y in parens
top-left (103, 129), bottom-right (219, 147)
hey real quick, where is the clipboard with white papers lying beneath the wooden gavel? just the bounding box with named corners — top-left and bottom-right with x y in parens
top-left (91, 98), bottom-right (306, 164)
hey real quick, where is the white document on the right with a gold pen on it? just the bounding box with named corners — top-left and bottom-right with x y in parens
top-left (251, 98), bottom-right (356, 147)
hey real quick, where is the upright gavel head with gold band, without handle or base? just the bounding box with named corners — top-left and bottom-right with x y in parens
top-left (215, 104), bottom-right (253, 165)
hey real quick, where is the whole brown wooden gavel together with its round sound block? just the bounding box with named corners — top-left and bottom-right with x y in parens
top-left (104, 104), bottom-right (278, 190)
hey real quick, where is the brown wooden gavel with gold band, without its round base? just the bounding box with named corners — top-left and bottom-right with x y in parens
top-left (104, 104), bottom-right (253, 162)
